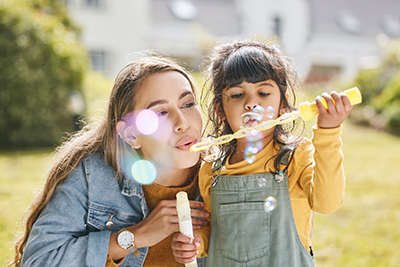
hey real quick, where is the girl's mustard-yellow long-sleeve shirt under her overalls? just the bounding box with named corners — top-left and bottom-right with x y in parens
top-left (196, 126), bottom-right (345, 257)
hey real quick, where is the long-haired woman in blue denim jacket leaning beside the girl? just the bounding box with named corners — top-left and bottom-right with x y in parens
top-left (13, 56), bottom-right (208, 267)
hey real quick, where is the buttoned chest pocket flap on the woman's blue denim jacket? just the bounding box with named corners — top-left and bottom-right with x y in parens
top-left (88, 203), bottom-right (143, 231)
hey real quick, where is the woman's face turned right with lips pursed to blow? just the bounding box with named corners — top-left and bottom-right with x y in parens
top-left (133, 71), bottom-right (202, 172)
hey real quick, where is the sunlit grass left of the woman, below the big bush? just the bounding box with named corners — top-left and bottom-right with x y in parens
top-left (0, 149), bottom-right (52, 266)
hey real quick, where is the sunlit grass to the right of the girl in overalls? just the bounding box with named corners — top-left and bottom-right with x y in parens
top-left (312, 123), bottom-right (400, 267)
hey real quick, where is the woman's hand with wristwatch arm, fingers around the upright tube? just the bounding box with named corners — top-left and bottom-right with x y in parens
top-left (128, 200), bottom-right (210, 248)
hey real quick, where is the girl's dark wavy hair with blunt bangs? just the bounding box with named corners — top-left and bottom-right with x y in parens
top-left (201, 40), bottom-right (305, 171)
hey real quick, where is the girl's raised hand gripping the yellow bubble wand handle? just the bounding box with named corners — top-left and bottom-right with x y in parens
top-left (315, 92), bottom-right (353, 128)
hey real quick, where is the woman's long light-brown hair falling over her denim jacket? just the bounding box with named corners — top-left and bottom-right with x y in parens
top-left (9, 56), bottom-right (199, 267)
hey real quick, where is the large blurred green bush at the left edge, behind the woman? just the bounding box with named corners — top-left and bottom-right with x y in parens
top-left (0, 0), bottom-right (88, 148)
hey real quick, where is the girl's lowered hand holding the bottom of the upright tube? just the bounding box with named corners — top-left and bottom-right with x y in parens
top-left (171, 233), bottom-right (201, 264)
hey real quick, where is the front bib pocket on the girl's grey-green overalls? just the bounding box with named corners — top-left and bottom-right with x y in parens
top-left (218, 202), bottom-right (270, 262)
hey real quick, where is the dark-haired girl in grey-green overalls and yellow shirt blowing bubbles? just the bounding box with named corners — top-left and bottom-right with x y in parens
top-left (172, 38), bottom-right (352, 267)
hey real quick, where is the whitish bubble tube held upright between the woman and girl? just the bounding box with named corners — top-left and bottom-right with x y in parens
top-left (176, 191), bottom-right (197, 267)
